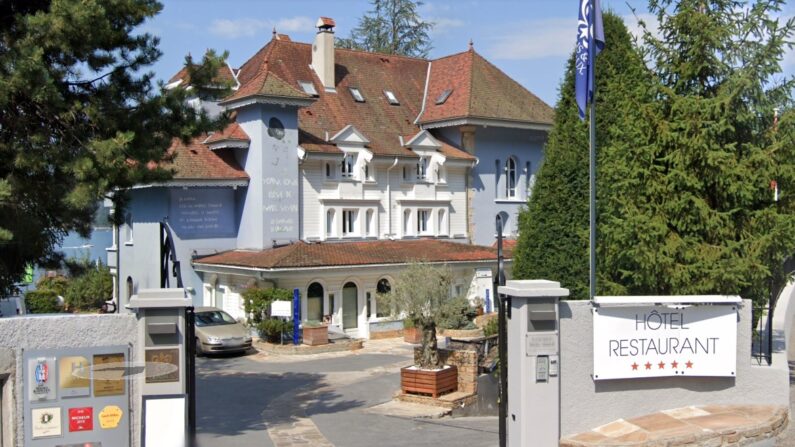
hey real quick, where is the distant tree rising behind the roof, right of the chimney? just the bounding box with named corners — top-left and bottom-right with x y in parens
top-left (337, 0), bottom-right (433, 57)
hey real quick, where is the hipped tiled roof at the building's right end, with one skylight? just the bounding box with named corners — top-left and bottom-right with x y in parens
top-left (420, 50), bottom-right (554, 124)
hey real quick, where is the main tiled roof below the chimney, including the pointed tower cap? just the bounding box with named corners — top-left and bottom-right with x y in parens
top-left (234, 39), bottom-right (474, 160)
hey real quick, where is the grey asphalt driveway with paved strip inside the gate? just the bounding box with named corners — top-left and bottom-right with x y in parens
top-left (196, 340), bottom-right (498, 447)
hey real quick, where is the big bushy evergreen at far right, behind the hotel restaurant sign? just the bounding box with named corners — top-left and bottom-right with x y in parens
top-left (600, 0), bottom-right (795, 299)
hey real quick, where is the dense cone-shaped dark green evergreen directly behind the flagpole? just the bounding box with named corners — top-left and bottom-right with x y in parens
top-left (513, 12), bottom-right (651, 299)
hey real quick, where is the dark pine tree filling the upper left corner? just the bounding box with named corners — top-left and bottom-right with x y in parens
top-left (0, 0), bottom-right (230, 296)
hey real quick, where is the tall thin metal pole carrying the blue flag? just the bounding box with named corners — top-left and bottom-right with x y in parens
top-left (588, 0), bottom-right (597, 301)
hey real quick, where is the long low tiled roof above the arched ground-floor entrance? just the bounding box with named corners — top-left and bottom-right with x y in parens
top-left (194, 239), bottom-right (504, 269)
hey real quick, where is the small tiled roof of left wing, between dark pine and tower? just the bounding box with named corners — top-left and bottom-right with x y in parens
top-left (159, 135), bottom-right (249, 180)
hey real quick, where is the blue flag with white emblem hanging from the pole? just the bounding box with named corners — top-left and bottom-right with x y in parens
top-left (574, 0), bottom-right (605, 120)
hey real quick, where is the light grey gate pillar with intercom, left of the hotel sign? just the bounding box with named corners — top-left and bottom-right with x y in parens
top-left (498, 280), bottom-right (569, 447)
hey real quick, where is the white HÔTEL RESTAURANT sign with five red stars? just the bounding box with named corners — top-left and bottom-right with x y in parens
top-left (593, 304), bottom-right (737, 380)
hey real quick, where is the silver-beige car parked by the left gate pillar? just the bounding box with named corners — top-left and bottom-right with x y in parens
top-left (194, 307), bottom-right (251, 355)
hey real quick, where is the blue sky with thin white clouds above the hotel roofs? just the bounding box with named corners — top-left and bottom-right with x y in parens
top-left (143, 0), bottom-right (795, 105)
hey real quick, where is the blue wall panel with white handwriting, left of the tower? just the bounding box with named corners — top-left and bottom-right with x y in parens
top-left (169, 188), bottom-right (237, 239)
